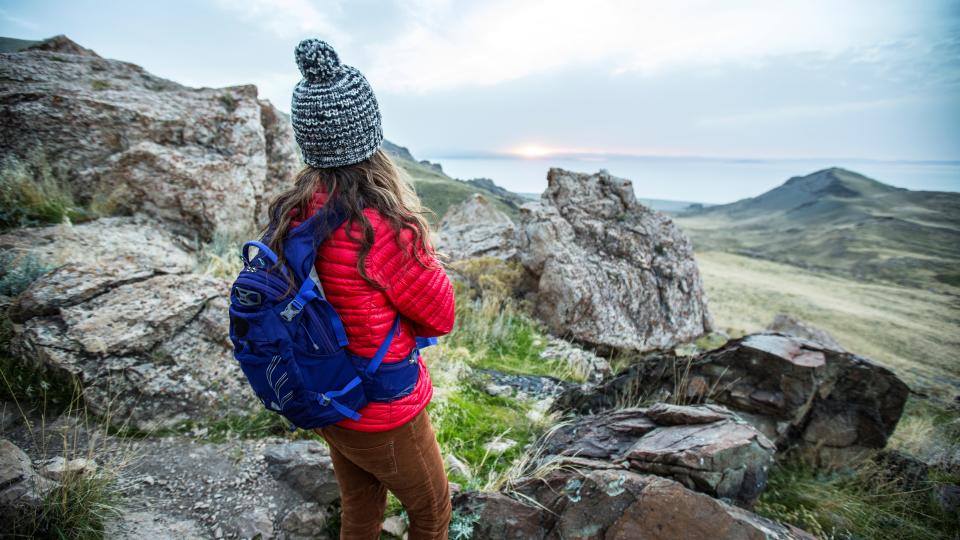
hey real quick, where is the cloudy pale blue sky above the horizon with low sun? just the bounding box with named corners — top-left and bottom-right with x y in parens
top-left (0, 0), bottom-right (960, 194)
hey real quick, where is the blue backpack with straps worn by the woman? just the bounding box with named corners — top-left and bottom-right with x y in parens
top-left (230, 205), bottom-right (436, 429)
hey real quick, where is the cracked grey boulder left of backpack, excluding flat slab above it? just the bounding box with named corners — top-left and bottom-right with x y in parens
top-left (11, 265), bottom-right (249, 431)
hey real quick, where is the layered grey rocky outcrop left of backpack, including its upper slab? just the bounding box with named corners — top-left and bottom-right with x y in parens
top-left (0, 218), bottom-right (253, 430)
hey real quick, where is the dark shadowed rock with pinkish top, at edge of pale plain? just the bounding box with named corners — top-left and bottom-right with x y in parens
top-left (554, 334), bottom-right (909, 467)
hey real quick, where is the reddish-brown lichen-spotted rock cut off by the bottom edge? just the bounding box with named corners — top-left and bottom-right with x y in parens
top-left (451, 469), bottom-right (814, 540)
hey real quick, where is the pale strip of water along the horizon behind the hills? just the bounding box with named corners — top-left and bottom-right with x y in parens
top-left (428, 157), bottom-right (960, 204)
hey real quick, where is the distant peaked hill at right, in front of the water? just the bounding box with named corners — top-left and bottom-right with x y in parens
top-left (675, 168), bottom-right (960, 288)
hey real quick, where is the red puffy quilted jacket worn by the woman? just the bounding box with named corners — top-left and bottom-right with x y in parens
top-left (291, 190), bottom-right (454, 431)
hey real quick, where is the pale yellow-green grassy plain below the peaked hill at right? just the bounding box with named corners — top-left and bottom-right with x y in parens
top-left (696, 251), bottom-right (960, 401)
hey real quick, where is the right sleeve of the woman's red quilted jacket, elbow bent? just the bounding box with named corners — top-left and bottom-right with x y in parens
top-left (366, 216), bottom-right (454, 337)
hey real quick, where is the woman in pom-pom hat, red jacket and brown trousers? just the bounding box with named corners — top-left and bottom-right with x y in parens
top-left (269, 39), bottom-right (454, 539)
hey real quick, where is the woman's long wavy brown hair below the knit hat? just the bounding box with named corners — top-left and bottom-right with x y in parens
top-left (262, 149), bottom-right (435, 290)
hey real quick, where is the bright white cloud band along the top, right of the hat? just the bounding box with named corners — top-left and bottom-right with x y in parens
top-left (366, 0), bottom-right (948, 92)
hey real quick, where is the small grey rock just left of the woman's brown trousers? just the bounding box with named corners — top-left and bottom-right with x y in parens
top-left (263, 441), bottom-right (340, 505)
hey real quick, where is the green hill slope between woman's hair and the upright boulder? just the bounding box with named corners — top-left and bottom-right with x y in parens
top-left (383, 141), bottom-right (524, 223)
